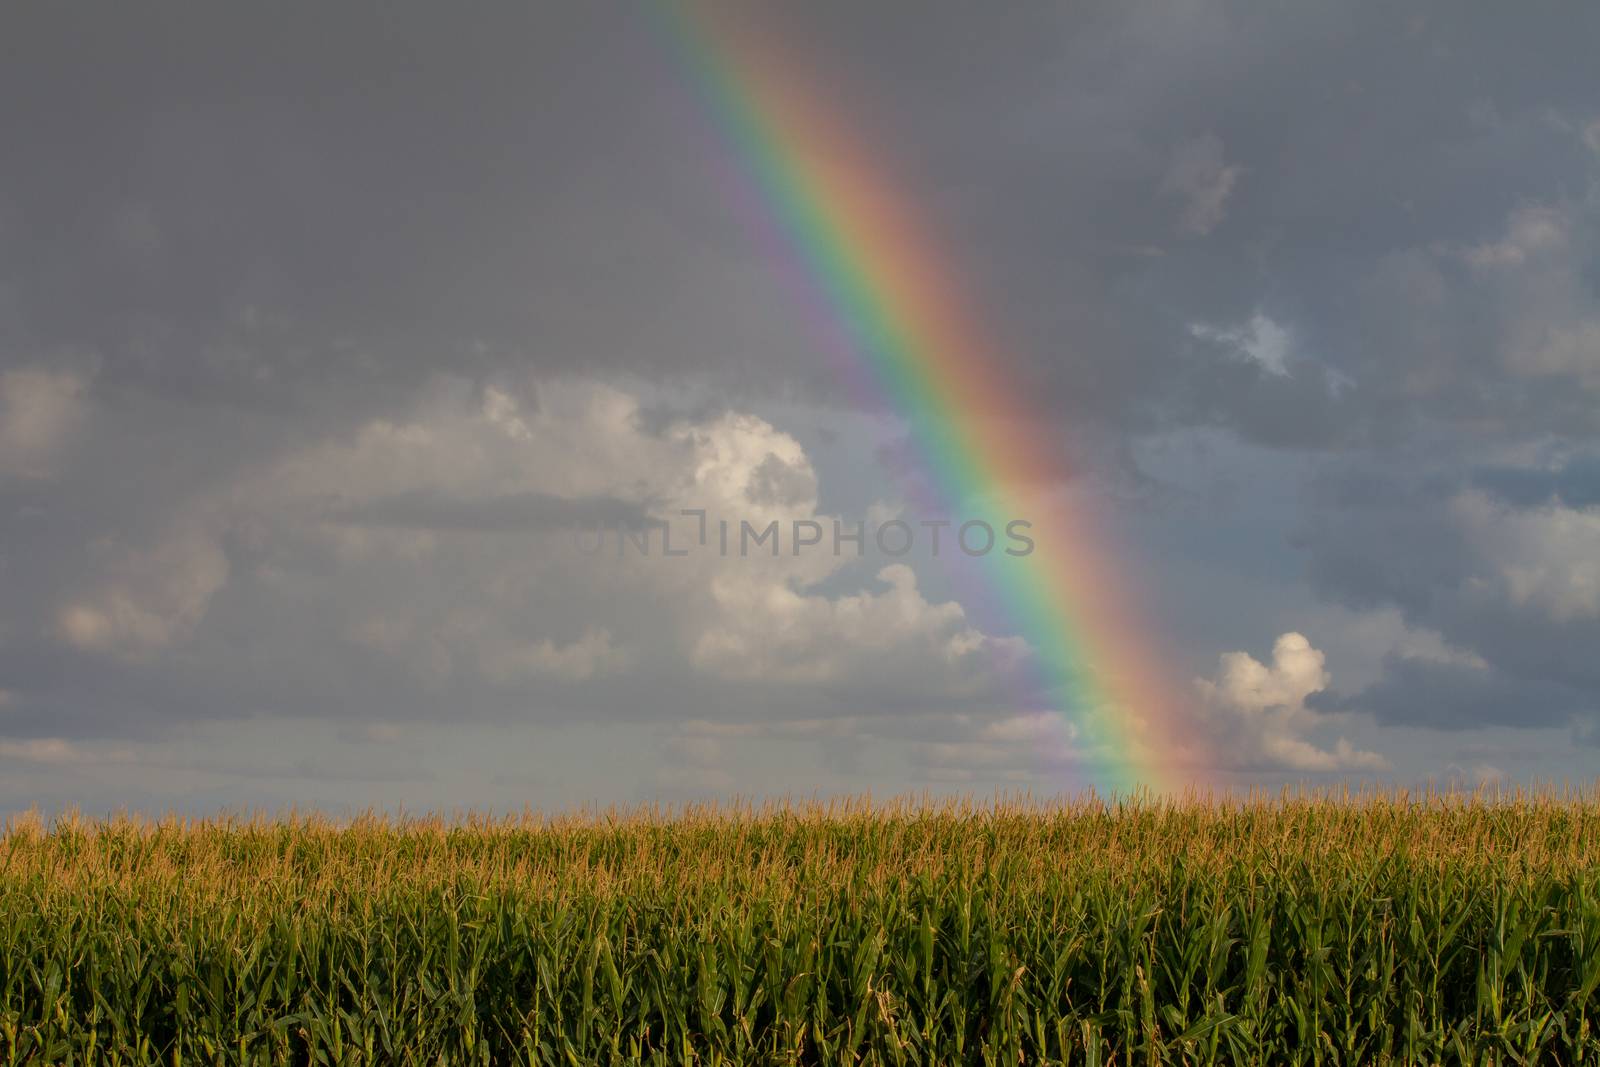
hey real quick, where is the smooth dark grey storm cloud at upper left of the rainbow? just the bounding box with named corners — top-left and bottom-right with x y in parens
top-left (0, 5), bottom-right (844, 410)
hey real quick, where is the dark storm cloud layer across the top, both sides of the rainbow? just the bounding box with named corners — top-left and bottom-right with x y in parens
top-left (0, 3), bottom-right (1600, 445)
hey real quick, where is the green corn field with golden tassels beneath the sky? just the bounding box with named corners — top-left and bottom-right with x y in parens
top-left (0, 792), bottom-right (1600, 1065)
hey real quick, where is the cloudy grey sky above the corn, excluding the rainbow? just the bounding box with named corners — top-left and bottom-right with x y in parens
top-left (0, 0), bottom-right (1600, 814)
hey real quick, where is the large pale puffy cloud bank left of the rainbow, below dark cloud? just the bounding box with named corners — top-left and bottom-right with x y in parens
top-left (0, 381), bottom-right (1027, 755)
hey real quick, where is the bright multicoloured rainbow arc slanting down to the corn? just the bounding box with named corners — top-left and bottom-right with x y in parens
top-left (646, 0), bottom-right (1203, 793)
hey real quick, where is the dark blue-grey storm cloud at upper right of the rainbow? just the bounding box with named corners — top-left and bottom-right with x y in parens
top-left (768, 3), bottom-right (1600, 445)
